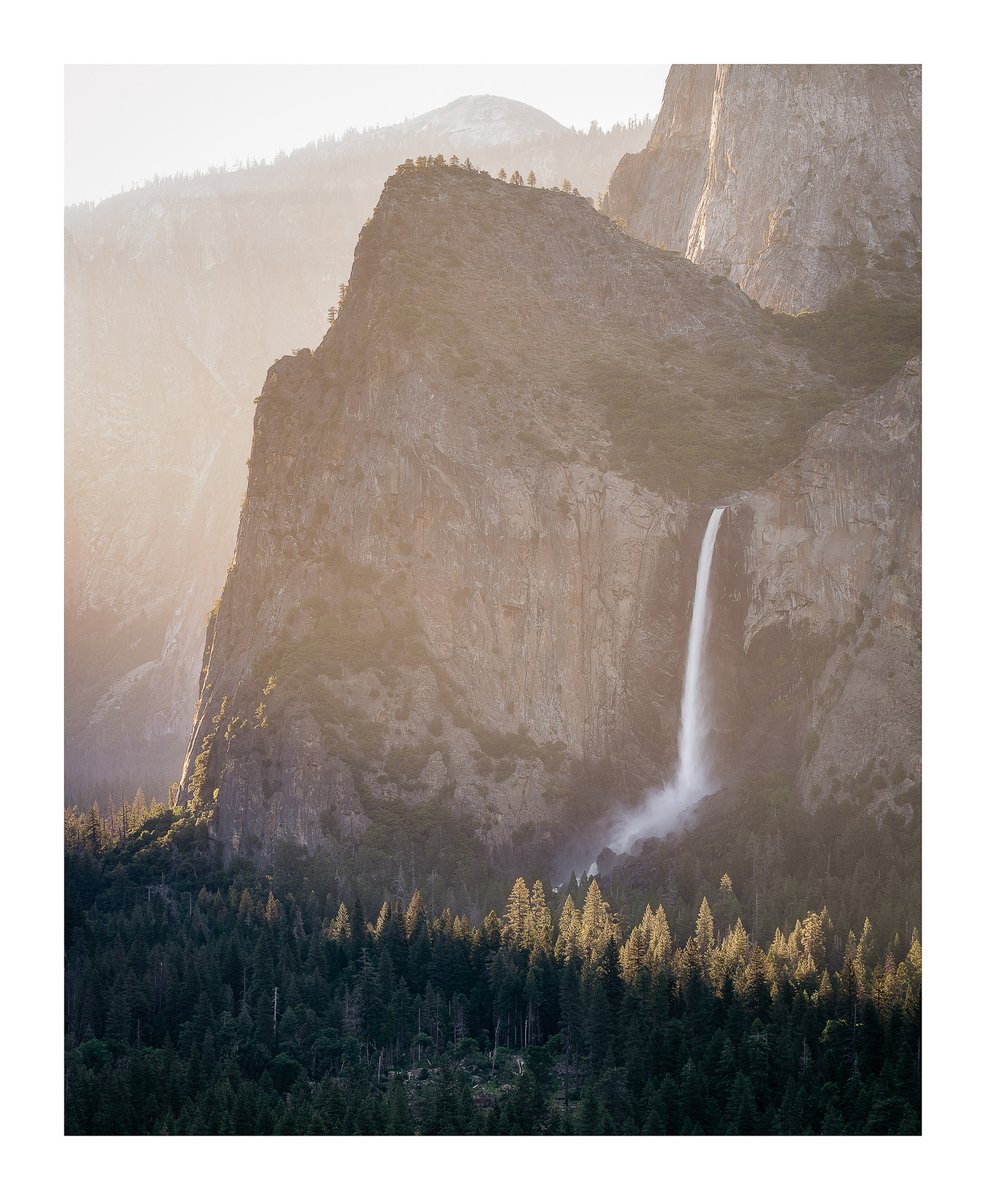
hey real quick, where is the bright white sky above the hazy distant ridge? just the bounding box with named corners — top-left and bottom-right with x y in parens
top-left (65, 65), bottom-right (668, 204)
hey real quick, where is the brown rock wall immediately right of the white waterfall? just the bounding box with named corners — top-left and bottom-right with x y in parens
top-left (726, 360), bottom-right (921, 803)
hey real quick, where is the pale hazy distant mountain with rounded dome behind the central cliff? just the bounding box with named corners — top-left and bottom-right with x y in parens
top-left (66, 97), bottom-right (643, 803)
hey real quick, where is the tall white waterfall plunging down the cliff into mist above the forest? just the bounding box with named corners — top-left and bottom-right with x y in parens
top-left (609, 508), bottom-right (725, 854)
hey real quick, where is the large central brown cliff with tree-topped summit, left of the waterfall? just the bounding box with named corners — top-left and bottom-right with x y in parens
top-left (182, 168), bottom-right (878, 854)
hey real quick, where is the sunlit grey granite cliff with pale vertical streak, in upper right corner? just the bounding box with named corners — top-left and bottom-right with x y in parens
top-left (607, 65), bottom-right (921, 313)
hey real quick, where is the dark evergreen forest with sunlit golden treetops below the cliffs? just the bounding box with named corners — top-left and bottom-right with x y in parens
top-left (65, 803), bottom-right (921, 1135)
